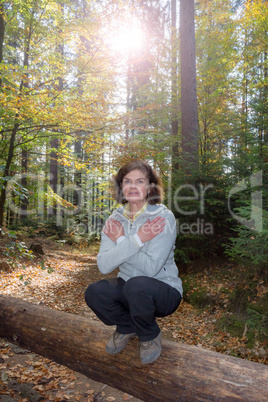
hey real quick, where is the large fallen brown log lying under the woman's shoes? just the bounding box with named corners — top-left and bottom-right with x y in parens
top-left (0, 296), bottom-right (268, 402)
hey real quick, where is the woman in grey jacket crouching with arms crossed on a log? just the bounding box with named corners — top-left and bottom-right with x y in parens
top-left (85, 161), bottom-right (182, 364)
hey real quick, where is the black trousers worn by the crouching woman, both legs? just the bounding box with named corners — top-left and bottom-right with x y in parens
top-left (85, 276), bottom-right (181, 342)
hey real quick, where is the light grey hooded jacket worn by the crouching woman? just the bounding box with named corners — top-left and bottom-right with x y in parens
top-left (97, 204), bottom-right (183, 295)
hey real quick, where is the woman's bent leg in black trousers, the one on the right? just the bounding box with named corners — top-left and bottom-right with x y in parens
top-left (123, 276), bottom-right (181, 342)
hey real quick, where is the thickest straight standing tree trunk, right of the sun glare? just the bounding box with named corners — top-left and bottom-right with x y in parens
top-left (180, 0), bottom-right (199, 174)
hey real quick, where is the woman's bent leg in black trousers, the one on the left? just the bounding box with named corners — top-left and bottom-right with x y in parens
top-left (85, 278), bottom-right (136, 334)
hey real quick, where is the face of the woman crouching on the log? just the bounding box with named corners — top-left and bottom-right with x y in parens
top-left (122, 169), bottom-right (149, 206)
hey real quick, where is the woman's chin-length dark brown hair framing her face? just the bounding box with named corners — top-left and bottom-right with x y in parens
top-left (113, 160), bottom-right (163, 205)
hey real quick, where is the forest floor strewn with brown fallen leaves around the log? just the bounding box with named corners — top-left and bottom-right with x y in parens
top-left (0, 241), bottom-right (267, 402)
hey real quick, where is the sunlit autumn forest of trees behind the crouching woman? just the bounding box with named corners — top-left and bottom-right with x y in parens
top-left (0, 0), bottom-right (268, 358)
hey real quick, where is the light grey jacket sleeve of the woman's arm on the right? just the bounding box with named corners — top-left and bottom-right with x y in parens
top-left (122, 213), bottom-right (176, 277)
